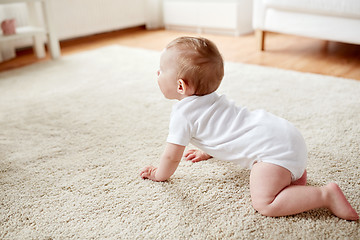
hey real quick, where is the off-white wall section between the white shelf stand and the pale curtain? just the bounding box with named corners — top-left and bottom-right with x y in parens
top-left (52, 0), bottom-right (146, 40)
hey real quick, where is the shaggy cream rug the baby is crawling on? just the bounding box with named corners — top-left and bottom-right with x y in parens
top-left (0, 46), bottom-right (360, 239)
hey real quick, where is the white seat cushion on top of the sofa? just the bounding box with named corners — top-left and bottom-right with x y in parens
top-left (264, 0), bottom-right (360, 18)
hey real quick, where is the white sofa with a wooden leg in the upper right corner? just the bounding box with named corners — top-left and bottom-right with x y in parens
top-left (253, 0), bottom-right (360, 50)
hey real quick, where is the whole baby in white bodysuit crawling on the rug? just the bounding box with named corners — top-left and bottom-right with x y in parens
top-left (140, 37), bottom-right (359, 220)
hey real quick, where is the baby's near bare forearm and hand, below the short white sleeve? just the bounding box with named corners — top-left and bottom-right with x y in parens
top-left (140, 143), bottom-right (185, 182)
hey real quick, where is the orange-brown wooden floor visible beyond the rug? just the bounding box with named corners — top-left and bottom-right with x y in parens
top-left (0, 27), bottom-right (360, 80)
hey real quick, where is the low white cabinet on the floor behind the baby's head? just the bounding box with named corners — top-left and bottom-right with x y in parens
top-left (163, 0), bottom-right (253, 35)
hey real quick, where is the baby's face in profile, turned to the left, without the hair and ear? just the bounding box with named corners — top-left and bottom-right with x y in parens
top-left (157, 48), bottom-right (179, 99)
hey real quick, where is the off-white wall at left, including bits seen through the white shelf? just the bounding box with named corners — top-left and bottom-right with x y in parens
top-left (0, 0), bottom-right (153, 47)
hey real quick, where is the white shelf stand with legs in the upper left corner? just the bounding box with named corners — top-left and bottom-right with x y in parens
top-left (0, 0), bottom-right (60, 62)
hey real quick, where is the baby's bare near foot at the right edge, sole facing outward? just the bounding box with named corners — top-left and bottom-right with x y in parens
top-left (325, 183), bottom-right (359, 220)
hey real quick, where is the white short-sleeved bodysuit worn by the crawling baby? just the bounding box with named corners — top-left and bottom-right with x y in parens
top-left (167, 92), bottom-right (307, 181)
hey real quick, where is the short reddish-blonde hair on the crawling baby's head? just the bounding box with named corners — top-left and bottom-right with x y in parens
top-left (166, 37), bottom-right (224, 96)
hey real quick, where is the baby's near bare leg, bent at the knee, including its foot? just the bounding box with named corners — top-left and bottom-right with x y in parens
top-left (250, 162), bottom-right (359, 220)
